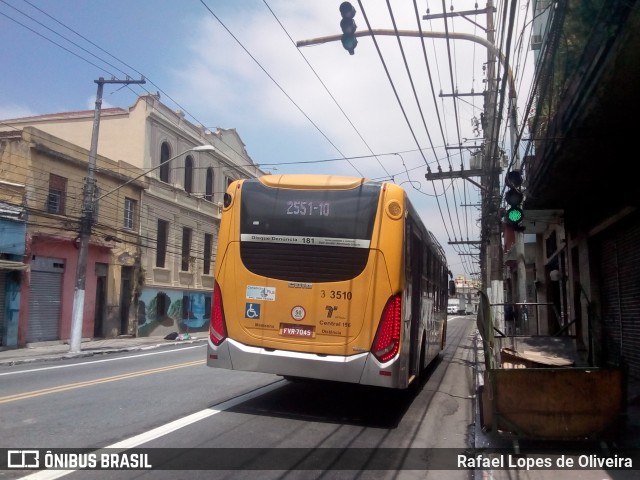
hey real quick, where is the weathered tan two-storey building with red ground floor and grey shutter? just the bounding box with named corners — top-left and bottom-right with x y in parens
top-left (0, 127), bottom-right (145, 348)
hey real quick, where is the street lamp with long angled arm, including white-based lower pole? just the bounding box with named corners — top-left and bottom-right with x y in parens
top-left (69, 145), bottom-right (215, 353)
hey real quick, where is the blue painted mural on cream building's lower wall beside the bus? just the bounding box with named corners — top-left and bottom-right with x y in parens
top-left (137, 288), bottom-right (211, 337)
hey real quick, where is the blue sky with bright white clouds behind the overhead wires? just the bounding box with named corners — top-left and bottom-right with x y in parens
top-left (0, 0), bottom-right (533, 278)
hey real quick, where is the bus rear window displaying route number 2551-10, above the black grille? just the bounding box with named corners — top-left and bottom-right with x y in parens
top-left (240, 180), bottom-right (380, 242)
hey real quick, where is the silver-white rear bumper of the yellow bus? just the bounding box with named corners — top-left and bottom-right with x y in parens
top-left (207, 338), bottom-right (406, 388)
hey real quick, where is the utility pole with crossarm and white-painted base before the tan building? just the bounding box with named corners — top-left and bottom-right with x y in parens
top-left (69, 77), bottom-right (146, 353)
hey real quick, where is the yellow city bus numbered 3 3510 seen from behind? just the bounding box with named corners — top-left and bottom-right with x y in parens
top-left (207, 175), bottom-right (453, 389)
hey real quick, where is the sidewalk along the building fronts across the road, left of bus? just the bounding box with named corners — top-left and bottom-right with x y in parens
top-left (0, 333), bottom-right (207, 366)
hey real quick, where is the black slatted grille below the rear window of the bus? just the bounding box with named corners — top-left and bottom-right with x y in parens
top-left (240, 242), bottom-right (369, 283)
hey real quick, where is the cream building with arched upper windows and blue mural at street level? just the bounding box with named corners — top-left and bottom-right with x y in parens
top-left (0, 95), bottom-right (264, 336)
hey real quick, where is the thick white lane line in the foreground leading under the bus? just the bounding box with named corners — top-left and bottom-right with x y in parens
top-left (21, 380), bottom-right (286, 480)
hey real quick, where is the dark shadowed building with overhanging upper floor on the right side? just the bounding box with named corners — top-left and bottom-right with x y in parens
top-left (504, 0), bottom-right (640, 386)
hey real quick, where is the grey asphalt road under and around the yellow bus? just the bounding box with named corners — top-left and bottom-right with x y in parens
top-left (0, 316), bottom-right (475, 479)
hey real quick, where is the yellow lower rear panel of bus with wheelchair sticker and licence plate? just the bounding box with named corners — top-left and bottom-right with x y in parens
top-left (218, 243), bottom-right (393, 355)
